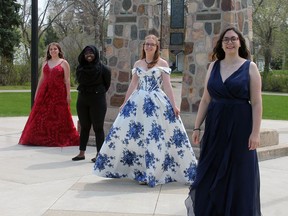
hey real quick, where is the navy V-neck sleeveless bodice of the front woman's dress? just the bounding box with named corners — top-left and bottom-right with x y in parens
top-left (207, 60), bottom-right (250, 101)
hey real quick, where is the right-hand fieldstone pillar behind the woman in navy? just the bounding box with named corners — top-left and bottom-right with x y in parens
top-left (181, 0), bottom-right (252, 129)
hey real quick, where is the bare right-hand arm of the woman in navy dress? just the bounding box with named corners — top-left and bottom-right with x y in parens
top-left (248, 62), bottom-right (262, 150)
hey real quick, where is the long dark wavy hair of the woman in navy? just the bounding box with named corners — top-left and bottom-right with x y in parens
top-left (212, 27), bottom-right (250, 60)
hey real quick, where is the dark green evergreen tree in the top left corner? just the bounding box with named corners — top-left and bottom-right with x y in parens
top-left (0, 0), bottom-right (21, 63)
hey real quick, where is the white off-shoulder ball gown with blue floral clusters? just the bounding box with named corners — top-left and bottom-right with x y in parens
top-left (94, 67), bottom-right (197, 187)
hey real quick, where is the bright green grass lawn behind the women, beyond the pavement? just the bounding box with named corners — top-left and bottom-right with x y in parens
top-left (0, 92), bottom-right (288, 120)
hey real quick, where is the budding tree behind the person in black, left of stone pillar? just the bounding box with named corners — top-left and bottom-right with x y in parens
top-left (50, 0), bottom-right (109, 71)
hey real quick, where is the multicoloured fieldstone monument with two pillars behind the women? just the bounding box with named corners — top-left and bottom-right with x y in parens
top-left (91, 0), bottom-right (288, 158)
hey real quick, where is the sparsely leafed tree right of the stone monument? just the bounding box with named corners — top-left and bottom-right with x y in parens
top-left (253, 0), bottom-right (288, 73)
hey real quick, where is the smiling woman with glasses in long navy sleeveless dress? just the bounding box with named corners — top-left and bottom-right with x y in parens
top-left (186, 27), bottom-right (262, 216)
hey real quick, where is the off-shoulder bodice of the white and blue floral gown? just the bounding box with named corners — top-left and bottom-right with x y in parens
top-left (132, 67), bottom-right (171, 91)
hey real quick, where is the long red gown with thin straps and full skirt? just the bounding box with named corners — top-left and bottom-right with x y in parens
top-left (19, 63), bottom-right (79, 147)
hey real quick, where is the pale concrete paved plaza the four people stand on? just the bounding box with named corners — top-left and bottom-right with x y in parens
top-left (0, 117), bottom-right (288, 216)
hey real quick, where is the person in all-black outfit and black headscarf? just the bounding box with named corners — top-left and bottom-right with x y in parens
top-left (72, 45), bottom-right (111, 163)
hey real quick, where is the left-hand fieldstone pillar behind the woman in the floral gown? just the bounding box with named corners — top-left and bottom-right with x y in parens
top-left (105, 0), bottom-right (167, 128)
